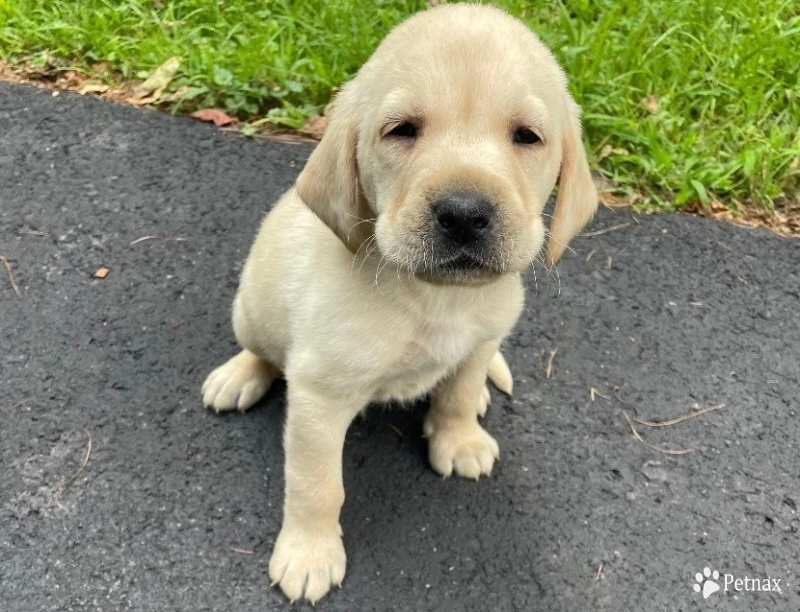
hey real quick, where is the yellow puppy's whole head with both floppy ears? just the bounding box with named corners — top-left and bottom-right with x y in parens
top-left (297, 5), bottom-right (597, 284)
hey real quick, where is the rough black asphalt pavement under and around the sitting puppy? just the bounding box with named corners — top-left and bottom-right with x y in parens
top-left (0, 84), bottom-right (800, 612)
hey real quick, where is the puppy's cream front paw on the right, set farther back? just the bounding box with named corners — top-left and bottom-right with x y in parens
top-left (424, 413), bottom-right (500, 480)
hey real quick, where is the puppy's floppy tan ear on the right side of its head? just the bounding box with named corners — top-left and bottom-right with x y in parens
top-left (547, 98), bottom-right (597, 266)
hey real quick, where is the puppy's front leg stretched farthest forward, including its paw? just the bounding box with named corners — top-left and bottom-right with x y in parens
top-left (269, 380), bottom-right (369, 603)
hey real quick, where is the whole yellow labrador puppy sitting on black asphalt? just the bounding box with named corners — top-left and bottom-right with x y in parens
top-left (203, 5), bottom-right (597, 602)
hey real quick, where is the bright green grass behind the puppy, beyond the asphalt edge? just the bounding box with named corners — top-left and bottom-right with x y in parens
top-left (0, 0), bottom-right (800, 208)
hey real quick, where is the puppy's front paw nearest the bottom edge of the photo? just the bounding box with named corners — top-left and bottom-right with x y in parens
top-left (269, 526), bottom-right (347, 604)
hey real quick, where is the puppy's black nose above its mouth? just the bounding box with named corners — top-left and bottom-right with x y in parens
top-left (432, 191), bottom-right (495, 246)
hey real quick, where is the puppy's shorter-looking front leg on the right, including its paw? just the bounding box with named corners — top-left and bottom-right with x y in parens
top-left (424, 341), bottom-right (500, 480)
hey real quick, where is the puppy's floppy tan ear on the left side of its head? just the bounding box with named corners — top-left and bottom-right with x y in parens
top-left (297, 87), bottom-right (375, 253)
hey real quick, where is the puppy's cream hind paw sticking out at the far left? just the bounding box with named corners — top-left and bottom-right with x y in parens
top-left (202, 349), bottom-right (280, 412)
